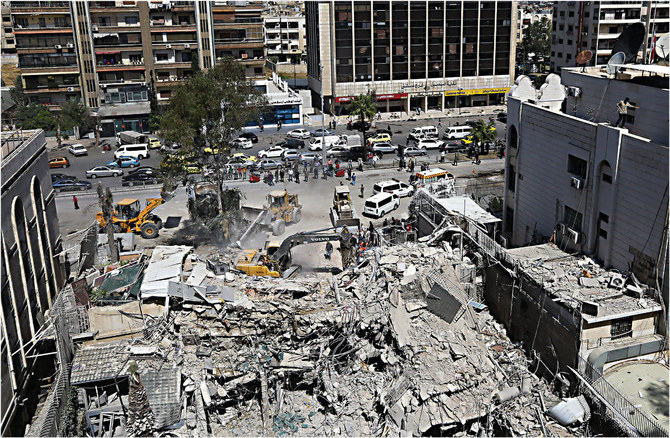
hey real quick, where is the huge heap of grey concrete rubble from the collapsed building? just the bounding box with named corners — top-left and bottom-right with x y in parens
top-left (56, 236), bottom-right (579, 436)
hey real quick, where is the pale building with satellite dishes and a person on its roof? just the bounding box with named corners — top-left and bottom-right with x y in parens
top-left (503, 65), bottom-right (670, 290)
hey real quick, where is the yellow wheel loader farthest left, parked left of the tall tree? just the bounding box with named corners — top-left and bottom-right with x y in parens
top-left (95, 198), bottom-right (164, 239)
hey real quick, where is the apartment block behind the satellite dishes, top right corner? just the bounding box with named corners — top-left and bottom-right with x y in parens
top-left (551, 0), bottom-right (670, 72)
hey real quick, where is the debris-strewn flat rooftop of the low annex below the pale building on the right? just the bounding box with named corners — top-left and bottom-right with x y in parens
top-left (507, 243), bottom-right (661, 323)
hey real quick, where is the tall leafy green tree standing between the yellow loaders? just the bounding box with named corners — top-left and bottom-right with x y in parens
top-left (160, 58), bottom-right (267, 233)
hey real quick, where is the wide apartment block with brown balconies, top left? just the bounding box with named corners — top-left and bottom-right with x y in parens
top-left (10, 0), bottom-right (265, 136)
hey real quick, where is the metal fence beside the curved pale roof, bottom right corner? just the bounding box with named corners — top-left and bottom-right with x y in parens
top-left (577, 357), bottom-right (670, 437)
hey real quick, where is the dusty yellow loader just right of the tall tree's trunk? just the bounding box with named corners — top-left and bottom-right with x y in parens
top-left (238, 190), bottom-right (302, 241)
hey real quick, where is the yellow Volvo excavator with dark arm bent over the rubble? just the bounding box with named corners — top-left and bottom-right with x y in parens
top-left (235, 227), bottom-right (354, 278)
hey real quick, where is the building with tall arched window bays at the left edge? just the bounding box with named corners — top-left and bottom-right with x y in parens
top-left (0, 130), bottom-right (66, 436)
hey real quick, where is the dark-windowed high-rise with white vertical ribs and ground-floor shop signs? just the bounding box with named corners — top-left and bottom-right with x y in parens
top-left (306, 1), bottom-right (516, 114)
